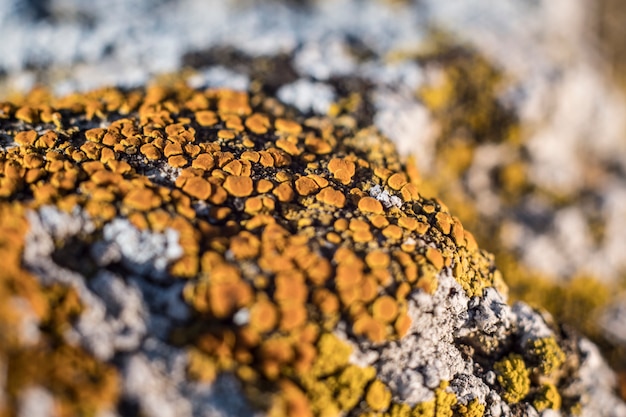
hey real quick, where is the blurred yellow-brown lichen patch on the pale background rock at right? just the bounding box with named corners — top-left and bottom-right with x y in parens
top-left (416, 33), bottom-right (626, 398)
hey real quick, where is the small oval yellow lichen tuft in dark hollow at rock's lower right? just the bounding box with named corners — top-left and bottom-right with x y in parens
top-left (494, 353), bottom-right (530, 404)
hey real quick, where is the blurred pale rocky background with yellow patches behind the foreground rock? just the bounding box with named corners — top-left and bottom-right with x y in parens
top-left (0, 0), bottom-right (626, 398)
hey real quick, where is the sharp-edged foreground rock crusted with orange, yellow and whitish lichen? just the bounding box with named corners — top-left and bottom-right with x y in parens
top-left (0, 75), bottom-right (626, 416)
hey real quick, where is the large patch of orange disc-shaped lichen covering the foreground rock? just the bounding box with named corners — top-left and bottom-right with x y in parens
top-left (0, 83), bottom-right (502, 415)
